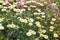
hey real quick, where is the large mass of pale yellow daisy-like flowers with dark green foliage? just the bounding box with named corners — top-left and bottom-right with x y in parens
top-left (0, 1), bottom-right (60, 40)
